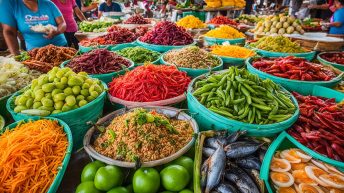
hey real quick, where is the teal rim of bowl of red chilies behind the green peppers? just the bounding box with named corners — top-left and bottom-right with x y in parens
top-left (245, 57), bottom-right (344, 84)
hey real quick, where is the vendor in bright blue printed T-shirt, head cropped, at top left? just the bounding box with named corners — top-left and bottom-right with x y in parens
top-left (0, 0), bottom-right (67, 55)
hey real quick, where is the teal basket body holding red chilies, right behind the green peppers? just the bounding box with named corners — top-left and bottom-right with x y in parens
top-left (246, 58), bottom-right (344, 95)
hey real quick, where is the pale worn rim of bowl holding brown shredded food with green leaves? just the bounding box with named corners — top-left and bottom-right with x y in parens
top-left (84, 106), bottom-right (198, 168)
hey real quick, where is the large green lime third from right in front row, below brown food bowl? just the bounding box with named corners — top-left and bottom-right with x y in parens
top-left (94, 165), bottom-right (124, 191)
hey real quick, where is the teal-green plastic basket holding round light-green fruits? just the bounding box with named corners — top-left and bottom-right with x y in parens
top-left (6, 82), bottom-right (107, 151)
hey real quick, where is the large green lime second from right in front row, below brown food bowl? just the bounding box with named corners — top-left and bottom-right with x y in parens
top-left (133, 168), bottom-right (160, 193)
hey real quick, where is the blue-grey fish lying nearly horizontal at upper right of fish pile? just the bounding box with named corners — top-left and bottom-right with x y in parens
top-left (224, 141), bottom-right (263, 159)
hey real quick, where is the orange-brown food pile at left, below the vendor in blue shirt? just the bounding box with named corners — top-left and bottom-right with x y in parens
top-left (16, 44), bottom-right (77, 73)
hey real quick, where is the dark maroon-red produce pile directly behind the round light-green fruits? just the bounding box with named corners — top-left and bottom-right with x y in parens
top-left (66, 49), bottom-right (131, 74)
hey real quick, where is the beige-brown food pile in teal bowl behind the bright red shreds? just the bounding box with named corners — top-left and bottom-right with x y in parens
top-left (163, 46), bottom-right (221, 69)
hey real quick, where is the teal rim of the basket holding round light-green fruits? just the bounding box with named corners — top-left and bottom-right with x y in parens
top-left (6, 80), bottom-right (108, 118)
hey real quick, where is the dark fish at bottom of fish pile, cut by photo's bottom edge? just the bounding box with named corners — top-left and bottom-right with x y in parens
top-left (225, 165), bottom-right (260, 193)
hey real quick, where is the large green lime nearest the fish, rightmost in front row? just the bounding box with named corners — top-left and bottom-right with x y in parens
top-left (160, 165), bottom-right (190, 191)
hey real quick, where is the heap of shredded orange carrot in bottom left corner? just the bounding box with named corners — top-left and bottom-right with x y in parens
top-left (0, 120), bottom-right (68, 193)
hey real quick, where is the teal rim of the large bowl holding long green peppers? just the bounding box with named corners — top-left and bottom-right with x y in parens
top-left (187, 69), bottom-right (300, 131)
